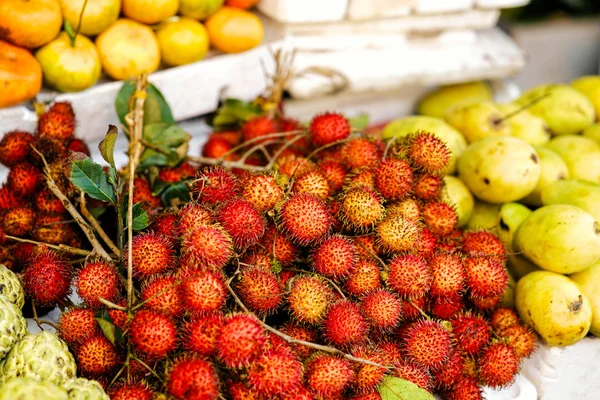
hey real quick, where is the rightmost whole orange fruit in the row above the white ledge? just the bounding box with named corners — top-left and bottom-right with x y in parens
top-left (206, 7), bottom-right (264, 53)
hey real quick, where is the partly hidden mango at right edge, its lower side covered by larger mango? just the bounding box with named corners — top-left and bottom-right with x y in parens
top-left (542, 179), bottom-right (600, 221)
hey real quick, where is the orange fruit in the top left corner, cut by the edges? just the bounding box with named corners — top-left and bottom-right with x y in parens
top-left (0, 0), bottom-right (62, 49)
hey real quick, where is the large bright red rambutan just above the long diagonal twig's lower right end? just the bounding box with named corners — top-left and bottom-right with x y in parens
top-left (401, 320), bottom-right (452, 368)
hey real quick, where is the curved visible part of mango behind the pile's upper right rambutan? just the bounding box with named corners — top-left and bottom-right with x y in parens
top-left (381, 115), bottom-right (467, 174)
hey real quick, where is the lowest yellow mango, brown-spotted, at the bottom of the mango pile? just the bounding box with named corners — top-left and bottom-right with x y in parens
top-left (515, 271), bottom-right (592, 346)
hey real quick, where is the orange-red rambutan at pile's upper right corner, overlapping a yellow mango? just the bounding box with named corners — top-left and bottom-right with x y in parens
top-left (407, 132), bottom-right (450, 174)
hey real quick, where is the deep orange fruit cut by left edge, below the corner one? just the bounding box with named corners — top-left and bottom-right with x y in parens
top-left (0, 40), bottom-right (42, 108)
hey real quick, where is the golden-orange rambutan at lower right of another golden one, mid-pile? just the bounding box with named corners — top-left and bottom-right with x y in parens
top-left (377, 215), bottom-right (421, 252)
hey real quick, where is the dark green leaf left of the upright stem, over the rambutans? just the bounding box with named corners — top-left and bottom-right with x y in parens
top-left (70, 158), bottom-right (116, 204)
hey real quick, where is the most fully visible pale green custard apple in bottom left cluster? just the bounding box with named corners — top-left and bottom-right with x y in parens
top-left (0, 331), bottom-right (77, 385)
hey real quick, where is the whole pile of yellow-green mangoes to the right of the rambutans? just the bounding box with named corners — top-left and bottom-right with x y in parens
top-left (382, 76), bottom-right (600, 346)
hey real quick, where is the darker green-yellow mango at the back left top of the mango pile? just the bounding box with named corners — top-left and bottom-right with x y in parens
top-left (417, 82), bottom-right (494, 118)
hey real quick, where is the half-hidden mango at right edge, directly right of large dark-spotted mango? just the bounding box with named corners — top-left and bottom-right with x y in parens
top-left (546, 135), bottom-right (600, 183)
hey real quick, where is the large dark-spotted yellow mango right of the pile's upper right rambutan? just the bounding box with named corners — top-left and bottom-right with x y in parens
top-left (457, 136), bottom-right (542, 204)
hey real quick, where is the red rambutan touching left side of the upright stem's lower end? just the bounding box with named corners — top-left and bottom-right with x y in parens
top-left (76, 261), bottom-right (120, 308)
